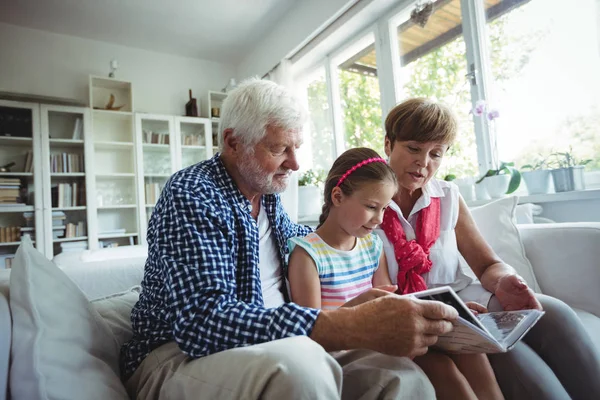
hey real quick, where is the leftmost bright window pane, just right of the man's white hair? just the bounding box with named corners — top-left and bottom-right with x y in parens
top-left (298, 67), bottom-right (335, 172)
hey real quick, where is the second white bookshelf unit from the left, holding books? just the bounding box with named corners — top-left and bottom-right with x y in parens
top-left (40, 105), bottom-right (95, 259)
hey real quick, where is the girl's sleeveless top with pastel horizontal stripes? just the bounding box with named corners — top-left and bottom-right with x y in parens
top-left (288, 233), bottom-right (382, 309)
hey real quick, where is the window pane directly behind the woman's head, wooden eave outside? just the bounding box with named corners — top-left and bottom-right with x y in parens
top-left (392, 0), bottom-right (478, 178)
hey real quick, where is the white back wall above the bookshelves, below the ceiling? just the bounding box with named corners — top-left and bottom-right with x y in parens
top-left (0, 24), bottom-right (235, 115)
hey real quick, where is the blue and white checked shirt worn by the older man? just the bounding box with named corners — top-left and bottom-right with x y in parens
top-left (121, 154), bottom-right (319, 377)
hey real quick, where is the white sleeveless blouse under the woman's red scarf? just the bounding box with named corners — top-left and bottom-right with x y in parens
top-left (375, 179), bottom-right (491, 305)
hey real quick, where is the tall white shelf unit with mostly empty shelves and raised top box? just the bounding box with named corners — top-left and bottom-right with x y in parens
top-left (85, 76), bottom-right (141, 249)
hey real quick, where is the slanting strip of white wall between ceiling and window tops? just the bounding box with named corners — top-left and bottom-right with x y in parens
top-left (237, 0), bottom-right (357, 79)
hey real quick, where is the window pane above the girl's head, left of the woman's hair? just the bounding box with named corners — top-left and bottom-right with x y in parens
top-left (336, 34), bottom-right (384, 155)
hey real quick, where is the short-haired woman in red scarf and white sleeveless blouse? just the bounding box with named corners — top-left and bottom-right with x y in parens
top-left (377, 99), bottom-right (600, 399)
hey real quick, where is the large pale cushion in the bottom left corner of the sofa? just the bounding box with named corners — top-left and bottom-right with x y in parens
top-left (10, 237), bottom-right (128, 400)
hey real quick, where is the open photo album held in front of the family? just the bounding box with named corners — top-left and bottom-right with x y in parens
top-left (409, 286), bottom-right (544, 353)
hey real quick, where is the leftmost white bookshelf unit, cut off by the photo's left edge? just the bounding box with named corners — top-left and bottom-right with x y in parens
top-left (0, 100), bottom-right (45, 268)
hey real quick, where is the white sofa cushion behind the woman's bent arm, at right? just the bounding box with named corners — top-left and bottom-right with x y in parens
top-left (468, 196), bottom-right (540, 292)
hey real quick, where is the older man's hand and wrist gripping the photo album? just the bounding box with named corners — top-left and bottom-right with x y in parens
top-left (311, 294), bottom-right (458, 357)
